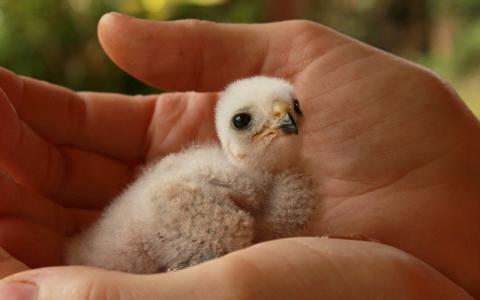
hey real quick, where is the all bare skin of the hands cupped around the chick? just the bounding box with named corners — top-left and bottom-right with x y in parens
top-left (0, 14), bottom-right (480, 299)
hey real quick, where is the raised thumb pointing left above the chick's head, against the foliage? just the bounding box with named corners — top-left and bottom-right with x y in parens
top-left (98, 13), bottom-right (345, 91)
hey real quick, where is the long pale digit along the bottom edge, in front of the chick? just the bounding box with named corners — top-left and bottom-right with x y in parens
top-left (0, 238), bottom-right (473, 300)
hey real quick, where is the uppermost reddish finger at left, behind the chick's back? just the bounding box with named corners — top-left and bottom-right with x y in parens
top-left (0, 68), bottom-right (156, 159)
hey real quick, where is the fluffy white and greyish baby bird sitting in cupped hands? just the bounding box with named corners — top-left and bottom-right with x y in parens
top-left (65, 76), bottom-right (315, 273)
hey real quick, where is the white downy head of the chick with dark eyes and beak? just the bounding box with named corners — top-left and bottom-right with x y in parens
top-left (216, 76), bottom-right (303, 172)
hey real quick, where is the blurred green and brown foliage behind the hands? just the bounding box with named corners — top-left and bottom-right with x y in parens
top-left (0, 0), bottom-right (480, 116)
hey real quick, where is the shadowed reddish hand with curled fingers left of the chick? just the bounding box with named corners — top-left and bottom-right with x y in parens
top-left (0, 55), bottom-right (215, 267)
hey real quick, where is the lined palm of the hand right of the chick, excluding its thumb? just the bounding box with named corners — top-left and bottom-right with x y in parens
top-left (299, 46), bottom-right (480, 286)
